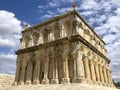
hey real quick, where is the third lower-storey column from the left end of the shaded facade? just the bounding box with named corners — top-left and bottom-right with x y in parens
top-left (26, 62), bottom-right (33, 85)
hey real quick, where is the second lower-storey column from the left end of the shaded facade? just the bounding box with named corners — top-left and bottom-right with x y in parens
top-left (19, 62), bottom-right (27, 85)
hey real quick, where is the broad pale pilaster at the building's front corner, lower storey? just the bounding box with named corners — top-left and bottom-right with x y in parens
top-left (72, 43), bottom-right (84, 83)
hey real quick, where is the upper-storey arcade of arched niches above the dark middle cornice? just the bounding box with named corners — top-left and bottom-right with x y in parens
top-left (20, 19), bottom-right (107, 56)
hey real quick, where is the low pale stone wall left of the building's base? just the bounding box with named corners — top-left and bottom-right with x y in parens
top-left (0, 74), bottom-right (14, 88)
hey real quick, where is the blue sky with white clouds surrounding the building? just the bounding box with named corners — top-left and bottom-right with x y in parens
top-left (0, 0), bottom-right (120, 81)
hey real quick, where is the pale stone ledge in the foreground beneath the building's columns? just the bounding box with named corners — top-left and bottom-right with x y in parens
top-left (0, 84), bottom-right (119, 90)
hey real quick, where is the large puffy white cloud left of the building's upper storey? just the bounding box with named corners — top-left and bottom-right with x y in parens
top-left (0, 10), bottom-right (22, 47)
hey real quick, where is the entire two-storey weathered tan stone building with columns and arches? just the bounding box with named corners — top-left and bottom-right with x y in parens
top-left (14, 5), bottom-right (114, 87)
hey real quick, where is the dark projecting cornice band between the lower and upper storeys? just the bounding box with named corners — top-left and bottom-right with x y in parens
top-left (16, 35), bottom-right (110, 63)
